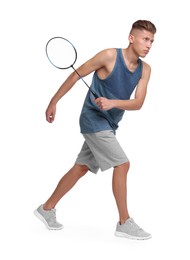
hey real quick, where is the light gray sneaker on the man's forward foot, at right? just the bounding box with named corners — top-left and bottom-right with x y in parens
top-left (115, 218), bottom-right (152, 240)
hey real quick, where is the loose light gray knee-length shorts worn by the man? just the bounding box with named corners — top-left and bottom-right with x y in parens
top-left (75, 130), bottom-right (128, 173)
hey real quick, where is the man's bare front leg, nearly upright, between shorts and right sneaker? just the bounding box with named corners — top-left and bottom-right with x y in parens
top-left (112, 162), bottom-right (130, 224)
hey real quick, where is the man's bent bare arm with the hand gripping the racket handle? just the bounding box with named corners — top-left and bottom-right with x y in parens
top-left (95, 62), bottom-right (151, 110)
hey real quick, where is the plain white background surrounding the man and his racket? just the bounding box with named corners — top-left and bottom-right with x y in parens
top-left (0, 0), bottom-right (190, 260)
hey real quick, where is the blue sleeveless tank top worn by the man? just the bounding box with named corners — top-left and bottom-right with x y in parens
top-left (80, 49), bottom-right (142, 134)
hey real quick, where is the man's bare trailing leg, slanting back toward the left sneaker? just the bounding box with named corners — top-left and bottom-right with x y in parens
top-left (43, 164), bottom-right (89, 210)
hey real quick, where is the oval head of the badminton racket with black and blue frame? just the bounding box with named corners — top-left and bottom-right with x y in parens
top-left (45, 36), bottom-right (77, 69)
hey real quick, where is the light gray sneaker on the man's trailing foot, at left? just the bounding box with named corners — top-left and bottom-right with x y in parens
top-left (34, 205), bottom-right (63, 230)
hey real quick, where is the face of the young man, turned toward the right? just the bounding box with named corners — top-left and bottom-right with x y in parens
top-left (129, 30), bottom-right (154, 58)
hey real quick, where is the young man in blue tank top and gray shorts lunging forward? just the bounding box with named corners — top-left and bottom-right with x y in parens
top-left (35, 20), bottom-right (156, 239)
